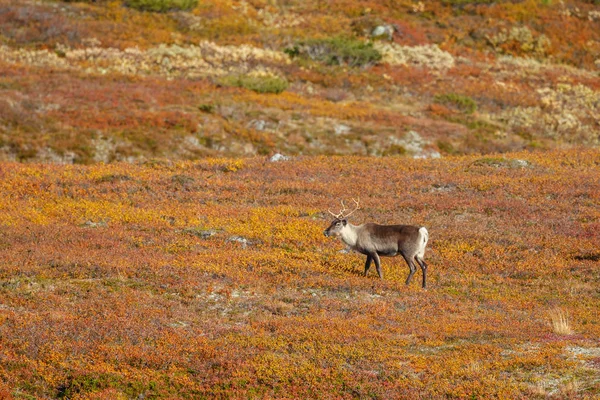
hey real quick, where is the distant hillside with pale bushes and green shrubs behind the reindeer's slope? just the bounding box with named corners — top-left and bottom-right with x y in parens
top-left (0, 0), bottom-right (600, 163)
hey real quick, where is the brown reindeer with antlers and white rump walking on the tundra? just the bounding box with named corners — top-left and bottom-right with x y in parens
top-left (323, 199), bottom-right (429, 288)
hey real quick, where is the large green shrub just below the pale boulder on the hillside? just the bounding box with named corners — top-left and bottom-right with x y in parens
top-left (285, 37), bottom-right (381, 67)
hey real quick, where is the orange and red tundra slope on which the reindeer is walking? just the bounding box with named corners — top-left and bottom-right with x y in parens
top-left (0, 150), bottom-right (600, 399)
